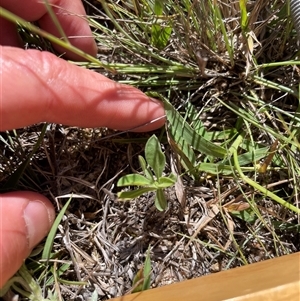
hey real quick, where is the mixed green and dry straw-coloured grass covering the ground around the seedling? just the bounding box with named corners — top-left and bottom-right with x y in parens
top-left (1, 0), bottom-right (300, 300)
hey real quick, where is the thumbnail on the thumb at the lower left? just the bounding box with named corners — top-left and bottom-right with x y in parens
top-left (24, 200), bottom-right (55, 249)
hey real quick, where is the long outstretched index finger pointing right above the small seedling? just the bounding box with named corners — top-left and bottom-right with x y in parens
top-left (0, 47), bottom-right (164, 131)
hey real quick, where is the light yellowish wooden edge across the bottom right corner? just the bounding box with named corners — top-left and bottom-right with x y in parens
top-left (110, 252), bottom-right (300, 301)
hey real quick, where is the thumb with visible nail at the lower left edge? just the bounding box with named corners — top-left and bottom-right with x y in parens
top-left (0, 192), bottom-right (55, 288)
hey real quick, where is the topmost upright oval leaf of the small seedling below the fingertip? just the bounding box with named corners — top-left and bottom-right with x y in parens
top-left (145, 135), bottom-right (166, 179)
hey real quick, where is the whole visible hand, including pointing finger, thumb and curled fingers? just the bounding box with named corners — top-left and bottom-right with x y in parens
top-left (0, 0), bottom-right (164, 288)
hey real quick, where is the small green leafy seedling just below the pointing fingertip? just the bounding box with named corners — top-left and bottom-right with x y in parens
top-left (117, 135), bottom-right (176, 211)
